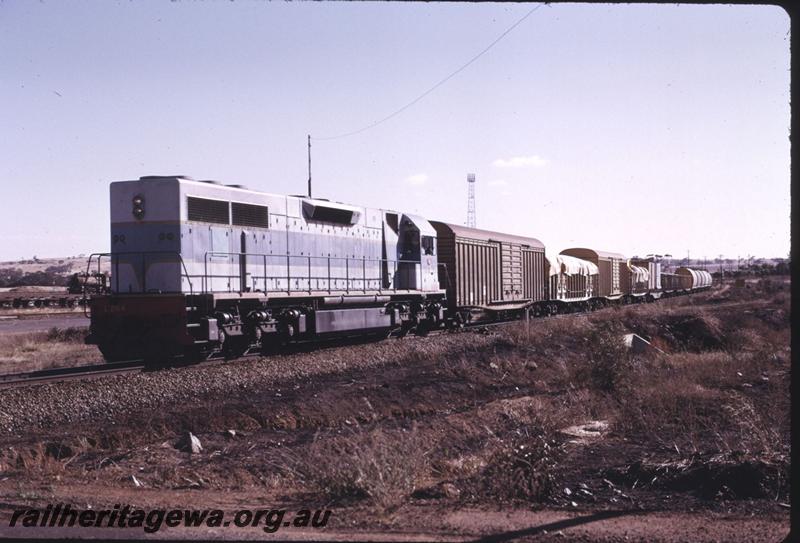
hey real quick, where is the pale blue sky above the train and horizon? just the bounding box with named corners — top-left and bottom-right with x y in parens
top-left (0, 0), bottom-right (790, 260)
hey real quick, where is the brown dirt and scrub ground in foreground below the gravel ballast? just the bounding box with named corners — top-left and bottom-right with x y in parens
top-left (0, 279), bottom-right (791, 542)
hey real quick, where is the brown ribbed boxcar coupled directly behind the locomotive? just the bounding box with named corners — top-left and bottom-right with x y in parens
top-left (431, 221), bottom-right (546, 311)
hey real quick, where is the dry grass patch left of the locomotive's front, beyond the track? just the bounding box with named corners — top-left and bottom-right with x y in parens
top-left (0, 328), bottom-right (103, 374)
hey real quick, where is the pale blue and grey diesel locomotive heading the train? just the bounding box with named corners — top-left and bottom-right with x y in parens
top-left (88, 176), bottom-right (445, 360)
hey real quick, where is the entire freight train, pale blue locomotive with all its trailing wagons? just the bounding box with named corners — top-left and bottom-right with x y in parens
top-left (86, 176), bottom-right (711, 363)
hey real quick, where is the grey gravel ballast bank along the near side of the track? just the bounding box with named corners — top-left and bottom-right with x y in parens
top-left (0, 333), bottom-right (500, 436)
